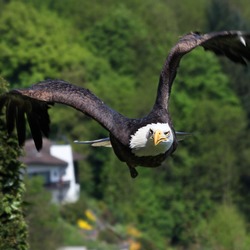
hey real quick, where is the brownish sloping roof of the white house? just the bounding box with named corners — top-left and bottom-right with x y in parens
top-left (19, 138), bottom-right (68, 167)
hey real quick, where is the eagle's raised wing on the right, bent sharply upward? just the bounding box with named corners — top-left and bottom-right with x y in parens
top-left (155, 31), bottom-right (250, 109)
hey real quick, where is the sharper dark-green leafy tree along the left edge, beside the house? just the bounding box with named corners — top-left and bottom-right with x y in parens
top-left (0, 78), bottom-right (28, 250)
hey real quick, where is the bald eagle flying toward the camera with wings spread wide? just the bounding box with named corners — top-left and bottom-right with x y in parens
top-left (0, 31), bottom-right (250, 177)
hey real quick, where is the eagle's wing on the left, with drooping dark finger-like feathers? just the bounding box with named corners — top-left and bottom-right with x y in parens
top-left (0, 80), bottom-right (126, 150)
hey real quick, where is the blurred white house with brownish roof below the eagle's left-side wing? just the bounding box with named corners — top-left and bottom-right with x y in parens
top-left (20, 139), bottom-right (80, 203)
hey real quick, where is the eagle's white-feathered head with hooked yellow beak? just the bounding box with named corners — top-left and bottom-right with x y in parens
top-left (130, 123), bottom-right (174, 156)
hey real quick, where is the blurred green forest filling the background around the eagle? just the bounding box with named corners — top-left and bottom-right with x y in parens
top-left (0, 0), bottom-right (250, 250)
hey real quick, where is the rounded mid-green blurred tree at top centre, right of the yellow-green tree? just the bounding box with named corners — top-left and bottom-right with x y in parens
top-left (86, 6), bottom-right (148, 75)
